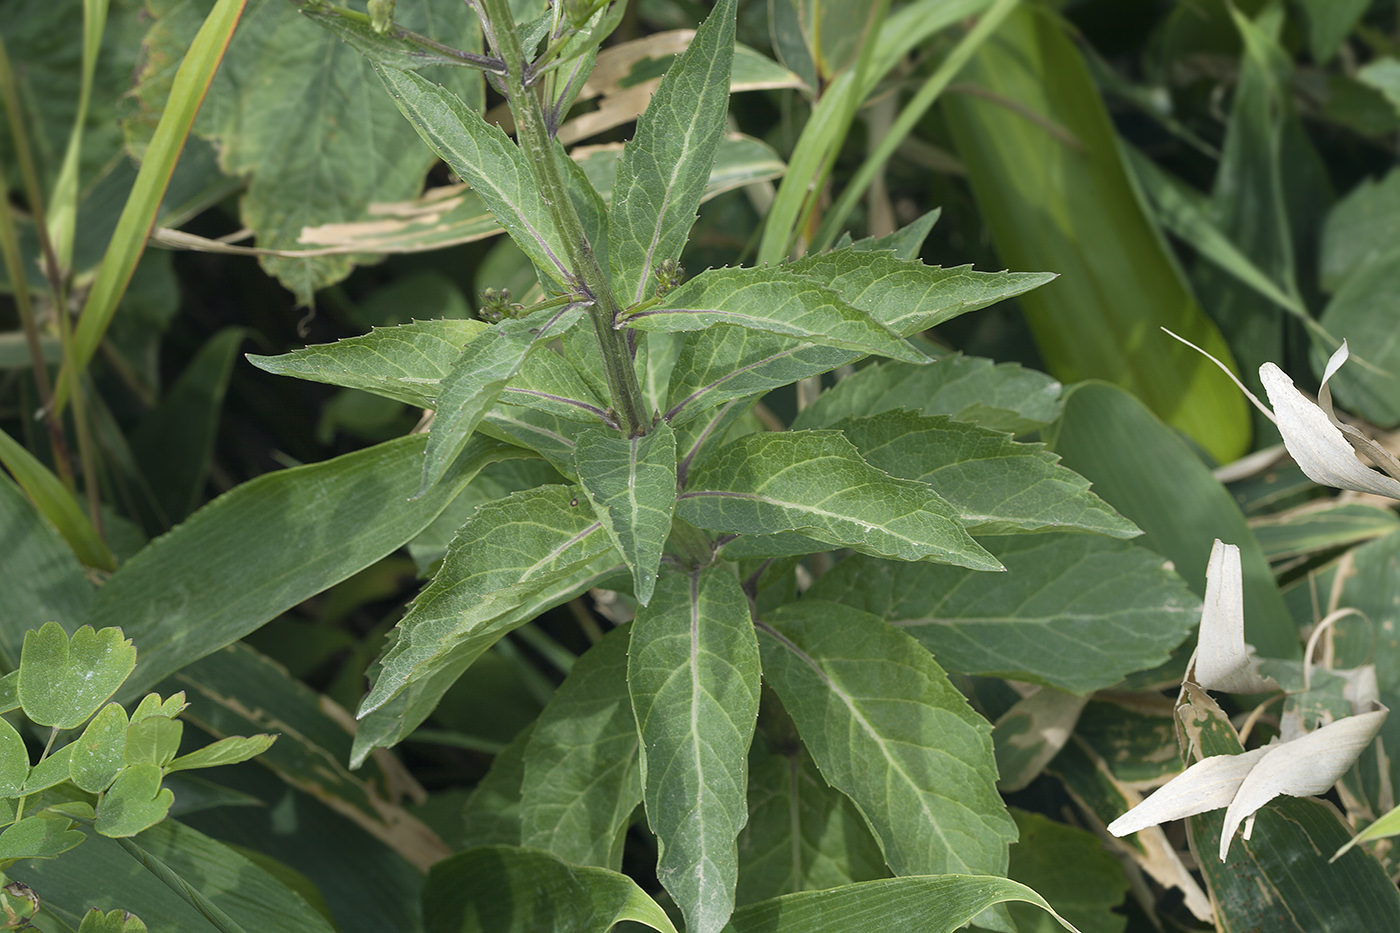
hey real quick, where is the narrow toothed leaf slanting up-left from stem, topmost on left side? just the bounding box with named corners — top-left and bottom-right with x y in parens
top-left (375, 66), bottom-right (571, 284)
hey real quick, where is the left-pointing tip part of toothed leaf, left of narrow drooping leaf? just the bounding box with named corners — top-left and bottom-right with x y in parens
top-left (248, 318), bottom-right (489, 408)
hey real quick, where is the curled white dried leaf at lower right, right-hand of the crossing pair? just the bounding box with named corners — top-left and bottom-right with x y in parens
top-left (1220, 709), bottom-right (1386, 862)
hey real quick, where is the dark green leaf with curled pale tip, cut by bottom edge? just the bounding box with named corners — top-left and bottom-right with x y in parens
top-left (423, 846), bottom-right (677, 933)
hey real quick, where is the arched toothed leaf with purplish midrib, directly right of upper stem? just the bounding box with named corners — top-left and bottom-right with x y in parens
top-left (622, 268), bottom-right (927, 363)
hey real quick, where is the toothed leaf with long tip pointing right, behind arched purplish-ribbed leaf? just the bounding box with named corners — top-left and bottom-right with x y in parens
top-left (780, 245), bottom-right (1056, 340)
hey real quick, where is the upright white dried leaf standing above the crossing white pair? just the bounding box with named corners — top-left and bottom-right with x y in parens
top-left (1187, 538), bottom-right (1278, 693)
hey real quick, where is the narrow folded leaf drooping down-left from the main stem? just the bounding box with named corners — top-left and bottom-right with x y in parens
top-left (414, 303), bottom-right (584, 497)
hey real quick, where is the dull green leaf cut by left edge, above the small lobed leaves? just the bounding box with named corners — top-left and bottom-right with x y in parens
top-left (0, 476), bottom-right (95, 664)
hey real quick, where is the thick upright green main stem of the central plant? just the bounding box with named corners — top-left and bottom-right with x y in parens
top-left (480, 0), bottom-right (651, 437)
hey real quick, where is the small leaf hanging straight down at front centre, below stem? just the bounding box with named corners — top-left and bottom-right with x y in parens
top-left (574, 422), bottom-right (676, 605)
